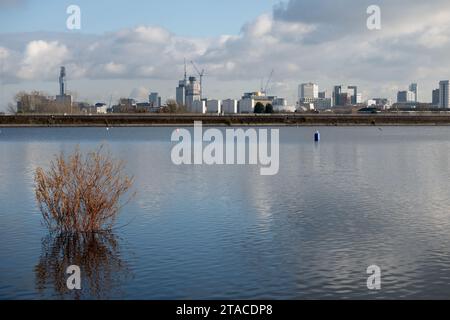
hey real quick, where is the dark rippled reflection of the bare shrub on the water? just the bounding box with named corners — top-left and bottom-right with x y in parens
top-left (35, 232), bottom-right (129, 299)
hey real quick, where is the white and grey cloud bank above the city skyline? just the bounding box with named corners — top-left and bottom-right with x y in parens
top-left (0, 0), bottom-right (450, 104)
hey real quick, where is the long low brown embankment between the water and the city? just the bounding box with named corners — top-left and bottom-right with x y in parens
top-left (0, 114), bottom-right (450, 128)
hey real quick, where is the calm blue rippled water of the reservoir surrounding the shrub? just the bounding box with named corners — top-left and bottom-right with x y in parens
top-left (0, 127), bottom-right (450, 299)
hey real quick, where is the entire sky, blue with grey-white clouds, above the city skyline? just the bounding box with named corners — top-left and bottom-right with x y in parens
top-left (0, 0), bottom-right (450, 111)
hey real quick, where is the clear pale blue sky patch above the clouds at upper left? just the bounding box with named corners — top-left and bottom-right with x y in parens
top-left (0, 0), bottom-right (279, 37)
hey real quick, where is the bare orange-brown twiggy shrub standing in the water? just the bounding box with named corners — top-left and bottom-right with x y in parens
top-left (35, 146), bottom-right (133, 233)
